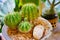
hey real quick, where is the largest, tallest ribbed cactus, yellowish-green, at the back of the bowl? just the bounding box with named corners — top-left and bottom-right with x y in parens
top-left (21, 3), bottom-right (39, 21)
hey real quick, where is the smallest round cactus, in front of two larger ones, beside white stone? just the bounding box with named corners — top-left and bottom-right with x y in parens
top-left (18, 21), bottom-right (33, 33)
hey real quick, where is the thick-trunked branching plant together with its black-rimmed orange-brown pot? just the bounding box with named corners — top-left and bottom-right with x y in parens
top-left (42, 0), bottom-right (60, 28)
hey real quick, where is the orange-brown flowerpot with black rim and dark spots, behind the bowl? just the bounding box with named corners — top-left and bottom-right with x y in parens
top-left (42, 14), bottom-right (58, 29)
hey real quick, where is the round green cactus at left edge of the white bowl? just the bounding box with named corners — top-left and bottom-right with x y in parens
top-left (4, 12), bottom-right (21, 29)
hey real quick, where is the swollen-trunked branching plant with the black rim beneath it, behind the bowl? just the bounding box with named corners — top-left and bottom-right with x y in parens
top-left (42, 0), bottom-right (60, 20)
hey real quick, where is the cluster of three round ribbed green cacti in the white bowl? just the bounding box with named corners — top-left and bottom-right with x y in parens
top-left (4, 3), bottom-right (39, 33)
